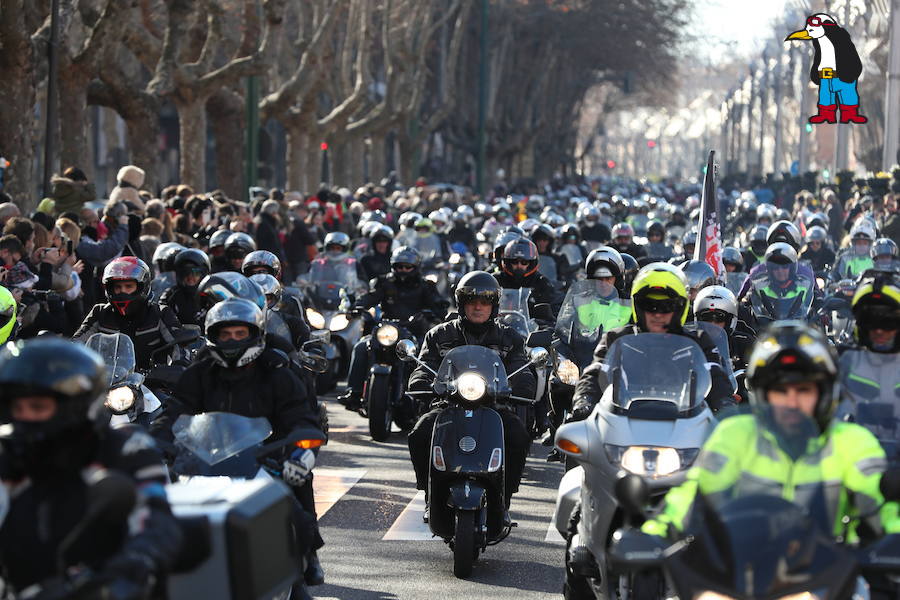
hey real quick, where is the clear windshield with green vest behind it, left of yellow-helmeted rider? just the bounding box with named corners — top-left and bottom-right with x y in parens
top-left (555, 279), bottom-right (631, 346)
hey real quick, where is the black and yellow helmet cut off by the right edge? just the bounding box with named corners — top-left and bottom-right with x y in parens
top-left (850, 273), bottom-right (900, 353)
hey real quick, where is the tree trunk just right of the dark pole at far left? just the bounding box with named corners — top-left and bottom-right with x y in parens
top-left (59, 67), bottom-right (94, 176)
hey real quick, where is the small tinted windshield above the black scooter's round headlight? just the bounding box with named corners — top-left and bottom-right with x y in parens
top-left (434, 346), bottom-right (510, 398)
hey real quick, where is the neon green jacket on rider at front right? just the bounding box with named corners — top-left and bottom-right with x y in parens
top-left (642, 415), bottom-right (900, 536)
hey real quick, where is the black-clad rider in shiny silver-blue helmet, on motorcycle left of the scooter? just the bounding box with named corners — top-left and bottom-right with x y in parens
top-left (169, 298), bottom-right (324, 585)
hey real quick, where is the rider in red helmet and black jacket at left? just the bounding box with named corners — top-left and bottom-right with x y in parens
top-left (72, 256), bottom-right (181, 369)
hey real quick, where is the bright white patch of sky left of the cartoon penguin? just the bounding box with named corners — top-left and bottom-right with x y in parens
top-left (691, 0), bottom-right (803, 57)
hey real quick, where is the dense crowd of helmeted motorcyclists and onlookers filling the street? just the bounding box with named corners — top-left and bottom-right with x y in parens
top-left (0, 166), bottom-right (900, 598)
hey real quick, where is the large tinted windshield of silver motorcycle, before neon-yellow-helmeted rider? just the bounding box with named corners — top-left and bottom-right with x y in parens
top-left (606, 333), bottom-right (712, 417)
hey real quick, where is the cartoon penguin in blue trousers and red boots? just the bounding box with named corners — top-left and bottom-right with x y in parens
top-left (784, 13), bottom-right (868, 125)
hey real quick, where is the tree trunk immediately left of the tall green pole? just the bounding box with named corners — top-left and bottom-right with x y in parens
top-left (206, 89), bottom-right (246, 198)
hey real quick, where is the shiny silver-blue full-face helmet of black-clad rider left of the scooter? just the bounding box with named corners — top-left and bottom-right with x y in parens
top-left (205, 298), bottom-right (266, 369)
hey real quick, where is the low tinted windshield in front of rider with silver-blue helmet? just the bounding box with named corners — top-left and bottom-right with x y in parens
top-left (172, 412), bottom-right (272, 466)
